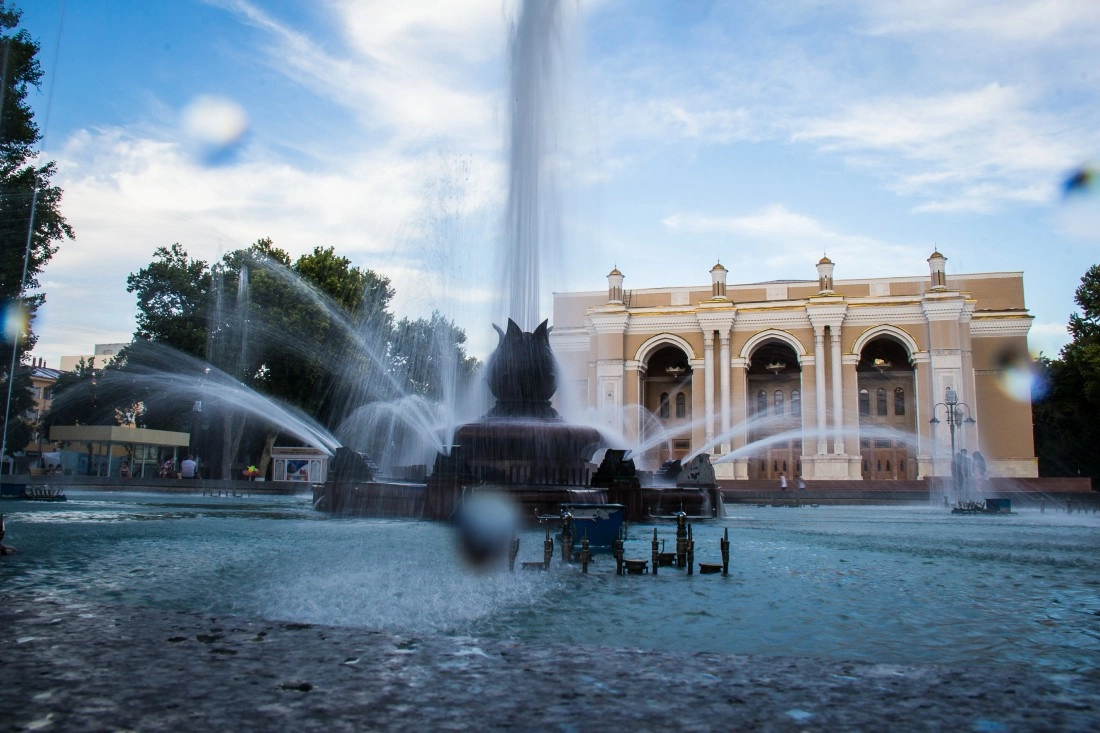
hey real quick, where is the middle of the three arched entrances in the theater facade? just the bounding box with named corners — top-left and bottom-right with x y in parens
top-left (746, 339), bottom-right (802, 481)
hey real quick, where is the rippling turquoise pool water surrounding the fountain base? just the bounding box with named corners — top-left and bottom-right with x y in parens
top-left (0, 494), bottom-right (1100, 670)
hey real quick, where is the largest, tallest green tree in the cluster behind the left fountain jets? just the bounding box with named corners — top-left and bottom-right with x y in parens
top-left (199, 239), bottom-right (394, 472)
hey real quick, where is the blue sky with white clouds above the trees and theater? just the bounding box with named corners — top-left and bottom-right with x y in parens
top-left (15, 0), bottom-right (1100, 367)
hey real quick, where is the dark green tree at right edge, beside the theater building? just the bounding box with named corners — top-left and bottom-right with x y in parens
top-left (1032, 265), bottom-right (1100, 485)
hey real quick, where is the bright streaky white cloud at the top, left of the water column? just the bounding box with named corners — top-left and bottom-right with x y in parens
top-left (217, 0), bottom-right (504, 151)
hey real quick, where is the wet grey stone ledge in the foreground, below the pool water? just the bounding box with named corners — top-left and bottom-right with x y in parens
top-left (0, 592), bottom-right (1100, 733)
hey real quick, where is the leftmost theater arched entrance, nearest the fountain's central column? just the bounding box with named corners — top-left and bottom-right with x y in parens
top-left (641, 344), bottom-right (692, 466)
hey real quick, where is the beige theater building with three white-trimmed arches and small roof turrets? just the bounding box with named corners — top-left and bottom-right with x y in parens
top-left (551, 251), bottom-right (1038, 480)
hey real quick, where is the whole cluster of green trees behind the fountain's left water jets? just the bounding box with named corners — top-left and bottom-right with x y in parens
top-left (116, 239), bottom-right (477, 471)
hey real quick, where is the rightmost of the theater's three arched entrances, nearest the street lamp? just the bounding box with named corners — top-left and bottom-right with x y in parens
top-left (856, 336), bottom-right (917, 480)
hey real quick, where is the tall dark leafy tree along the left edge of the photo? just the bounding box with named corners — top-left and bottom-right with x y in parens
top-left (0, 0), bottom-right (73, 462)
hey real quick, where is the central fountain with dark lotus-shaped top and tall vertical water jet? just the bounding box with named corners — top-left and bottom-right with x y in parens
top-left (315, 0), bottom-right (717, 521)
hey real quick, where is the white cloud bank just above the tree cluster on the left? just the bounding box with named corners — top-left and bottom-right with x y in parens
top-left (36, 122), bottom-right (499, 361)
